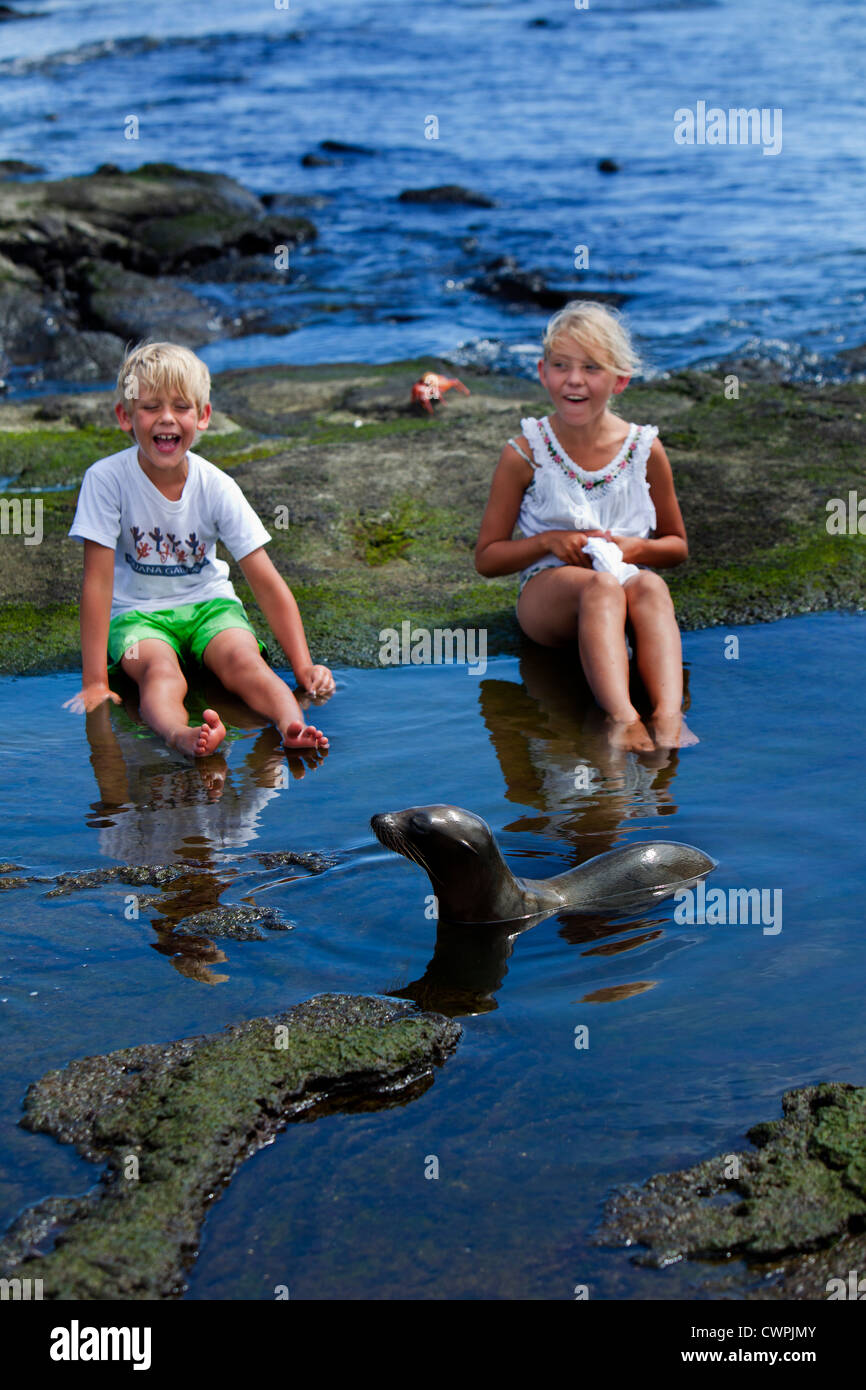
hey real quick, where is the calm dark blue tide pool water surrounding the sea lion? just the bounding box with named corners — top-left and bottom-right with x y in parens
top-left (0, 614), bottom-right (866, 1300)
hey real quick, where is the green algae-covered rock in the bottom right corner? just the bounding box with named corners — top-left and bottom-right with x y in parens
top-left (596, 1081), bottom-right (866, 1297)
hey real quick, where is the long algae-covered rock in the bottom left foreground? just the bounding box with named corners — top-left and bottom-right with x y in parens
top-left (0, 994), bottom-right (461, 1300)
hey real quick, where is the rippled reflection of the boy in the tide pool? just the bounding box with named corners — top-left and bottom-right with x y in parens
top-left (86, 675), bottom-right (322, 984)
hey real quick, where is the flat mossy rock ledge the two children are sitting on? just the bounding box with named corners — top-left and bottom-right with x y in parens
top-left (0, 350), bottom-right (866, 673)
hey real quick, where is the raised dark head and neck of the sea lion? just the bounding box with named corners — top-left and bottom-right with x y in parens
top-left (370, 806), bottom-right (525, 923)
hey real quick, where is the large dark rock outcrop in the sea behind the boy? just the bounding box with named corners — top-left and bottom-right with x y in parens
top-left (0, 164), bottom-right (317, 364)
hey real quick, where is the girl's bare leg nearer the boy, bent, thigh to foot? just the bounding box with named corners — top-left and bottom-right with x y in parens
top-left (517, 564), bottom-right (653, 751)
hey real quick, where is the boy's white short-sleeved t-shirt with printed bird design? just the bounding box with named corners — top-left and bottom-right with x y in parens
top-left (70, 445), bottom-right (271, 617)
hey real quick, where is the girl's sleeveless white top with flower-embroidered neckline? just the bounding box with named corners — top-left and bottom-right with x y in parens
top-left (510, 416), bottom-right (659, 591)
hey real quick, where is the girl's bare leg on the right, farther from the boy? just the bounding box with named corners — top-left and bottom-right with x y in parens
top-left (623, 570), bottom-right (698, 748)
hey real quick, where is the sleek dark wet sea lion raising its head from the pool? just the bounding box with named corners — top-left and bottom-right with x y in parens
top-left (370, 806), bottom-right (717, 926)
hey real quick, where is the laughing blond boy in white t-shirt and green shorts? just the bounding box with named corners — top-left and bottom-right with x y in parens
top-left (65, 343), bottom-right (335, 758)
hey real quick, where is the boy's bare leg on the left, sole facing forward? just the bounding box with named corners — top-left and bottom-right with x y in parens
top-left (121, 637), bottom-right (225, 758)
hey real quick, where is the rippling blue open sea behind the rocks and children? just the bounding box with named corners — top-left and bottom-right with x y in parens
top-left (0, 0), bottom-right (866, 386)
